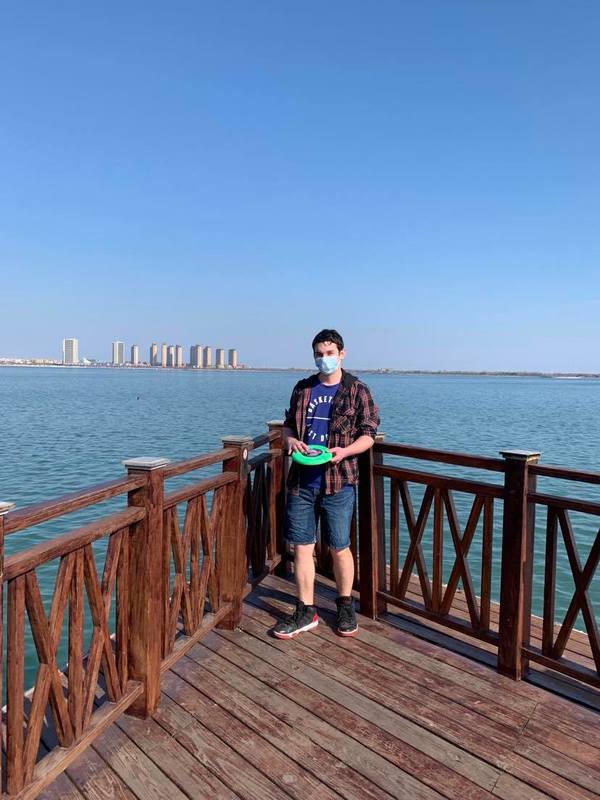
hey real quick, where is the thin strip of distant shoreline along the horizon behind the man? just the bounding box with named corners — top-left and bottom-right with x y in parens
top-left (0, 361), bottom-right (600, 380)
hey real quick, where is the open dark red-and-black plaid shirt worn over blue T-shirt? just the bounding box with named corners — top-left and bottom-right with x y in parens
top-left (285, 370), bottom-right (379, 494)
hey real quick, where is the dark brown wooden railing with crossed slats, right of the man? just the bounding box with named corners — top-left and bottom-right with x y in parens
top-left (358, 441), bottom-right (600, 686)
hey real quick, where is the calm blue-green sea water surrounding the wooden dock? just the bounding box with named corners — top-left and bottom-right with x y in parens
top-left (0, 368), bottom-right (600, 684)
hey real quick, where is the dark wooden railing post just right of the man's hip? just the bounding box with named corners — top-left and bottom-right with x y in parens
top-left (357, 434), bottom-right (385, 619)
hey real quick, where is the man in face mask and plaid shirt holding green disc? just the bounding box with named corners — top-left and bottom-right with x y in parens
top-left (273, 330), bottom-right (379, 639)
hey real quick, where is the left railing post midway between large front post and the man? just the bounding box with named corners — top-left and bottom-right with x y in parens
top-left (216, 436), bottom-right (252, 630)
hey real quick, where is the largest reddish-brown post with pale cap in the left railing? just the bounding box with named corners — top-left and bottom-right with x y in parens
top-left (123, 458), bottom-right (169, 717)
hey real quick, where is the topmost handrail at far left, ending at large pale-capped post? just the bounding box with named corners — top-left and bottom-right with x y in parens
top-left (4, 476), bottom-right (145, 534)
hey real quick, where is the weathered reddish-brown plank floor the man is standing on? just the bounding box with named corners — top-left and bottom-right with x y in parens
top-left (39, 577), bottom-right (600, 800)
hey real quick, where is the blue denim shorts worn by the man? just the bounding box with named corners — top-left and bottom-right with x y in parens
top-left (285, 486), bottom-right (355, 550)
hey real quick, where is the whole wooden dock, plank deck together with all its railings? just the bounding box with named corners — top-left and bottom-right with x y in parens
top-left (0, 422), bottom-right (600, 800)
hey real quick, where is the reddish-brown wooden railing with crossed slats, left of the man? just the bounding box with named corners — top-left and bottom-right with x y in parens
top-left (0, 425), bottom-right (283, 798)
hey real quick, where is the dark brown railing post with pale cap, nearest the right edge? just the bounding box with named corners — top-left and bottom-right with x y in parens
top-left (498, 450), bottom-right (540, 680)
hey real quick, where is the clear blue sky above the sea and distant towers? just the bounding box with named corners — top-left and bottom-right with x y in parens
top-left (0, 0), bottom-right (600, 371)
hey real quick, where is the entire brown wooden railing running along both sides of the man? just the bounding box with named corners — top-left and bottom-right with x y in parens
top-left (0, 423), bottom-right (600, 798)
